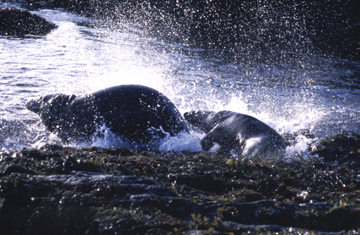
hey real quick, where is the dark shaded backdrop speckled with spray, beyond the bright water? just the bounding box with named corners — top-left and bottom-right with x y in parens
top-left (39, 0), bottom-right (360, 59)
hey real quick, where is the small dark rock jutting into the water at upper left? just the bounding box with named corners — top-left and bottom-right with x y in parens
top-left (0, 8), bottom-right (56, 37)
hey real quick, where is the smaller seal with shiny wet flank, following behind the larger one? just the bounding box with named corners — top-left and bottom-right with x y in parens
top-left (184, 111), bottom-right (286, 157)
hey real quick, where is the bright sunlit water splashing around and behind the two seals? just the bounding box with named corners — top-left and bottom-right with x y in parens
top-left (0, 4), bottom-right (360, 155)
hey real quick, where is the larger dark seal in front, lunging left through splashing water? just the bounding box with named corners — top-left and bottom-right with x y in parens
top-left (26, 85), bottom-right (188, 145)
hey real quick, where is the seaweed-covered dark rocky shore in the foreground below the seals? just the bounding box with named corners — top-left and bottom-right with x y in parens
top-left (0, 134), bottom-right (360, 234)
